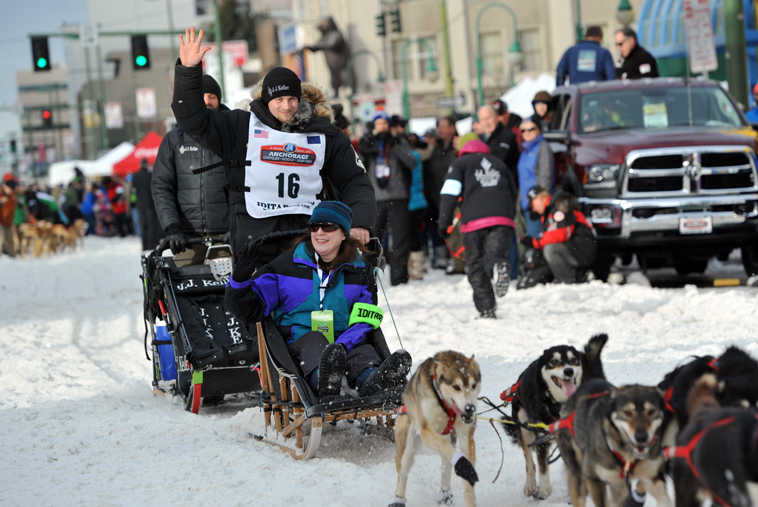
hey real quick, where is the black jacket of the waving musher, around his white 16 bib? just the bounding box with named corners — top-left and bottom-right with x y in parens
top-left (171, 60), bottom-right (376, 254)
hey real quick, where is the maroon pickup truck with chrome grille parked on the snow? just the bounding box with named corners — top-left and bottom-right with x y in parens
top-left (545, 78), bottom-right (758, 277)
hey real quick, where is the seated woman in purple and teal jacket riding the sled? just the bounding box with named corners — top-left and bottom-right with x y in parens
top-left (228, 201), bottom-right (411, 397)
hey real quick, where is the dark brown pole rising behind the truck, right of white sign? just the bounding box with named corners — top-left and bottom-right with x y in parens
top-left (723, 0), bottom-right (748, 107)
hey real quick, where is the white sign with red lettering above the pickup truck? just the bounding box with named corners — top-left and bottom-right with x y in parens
top-left (682, 0), bottom-right (719, 74)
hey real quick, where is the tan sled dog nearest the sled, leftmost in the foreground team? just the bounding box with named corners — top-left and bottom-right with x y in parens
top-left (390, 350), bottom-right (482, 507)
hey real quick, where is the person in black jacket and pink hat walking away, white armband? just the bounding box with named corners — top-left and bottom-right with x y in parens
top-left (439, 134), bottom-right (516, 319)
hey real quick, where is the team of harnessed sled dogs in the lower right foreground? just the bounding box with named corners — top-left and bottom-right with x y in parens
top-left (390, 334), bottom-right (758, 507)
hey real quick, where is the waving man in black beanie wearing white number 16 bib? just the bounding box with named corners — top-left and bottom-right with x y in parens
top-left (172, 27), bottom-right (376, 281)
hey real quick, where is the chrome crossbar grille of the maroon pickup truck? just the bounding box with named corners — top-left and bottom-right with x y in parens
top-left (623, 146), bottom-right (757, 197)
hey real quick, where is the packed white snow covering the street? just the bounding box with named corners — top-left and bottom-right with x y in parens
top-left (0, 237), bottom-right (758, 507)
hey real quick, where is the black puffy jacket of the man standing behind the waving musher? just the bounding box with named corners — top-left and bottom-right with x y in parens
top-left (152, 118), bottom-right (229, 236)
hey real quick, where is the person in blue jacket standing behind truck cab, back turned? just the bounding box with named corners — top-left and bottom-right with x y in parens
top-left (555, 26), bottom-right (616, 86)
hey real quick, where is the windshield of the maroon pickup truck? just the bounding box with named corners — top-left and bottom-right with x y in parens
top-left (579, 86), bottom-right (743, 132)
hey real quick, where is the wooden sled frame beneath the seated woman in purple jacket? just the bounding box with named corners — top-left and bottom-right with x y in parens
top-left (253, 320), bottom-right (404, 459)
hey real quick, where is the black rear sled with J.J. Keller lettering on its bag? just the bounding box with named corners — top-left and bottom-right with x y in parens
top-left (142, 239), bottom-right (260, 413)
